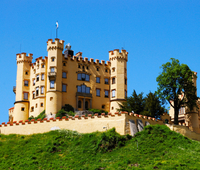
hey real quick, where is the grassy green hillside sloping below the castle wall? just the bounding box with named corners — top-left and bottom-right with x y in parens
top-left (0, 125), bottom-right (200, 170)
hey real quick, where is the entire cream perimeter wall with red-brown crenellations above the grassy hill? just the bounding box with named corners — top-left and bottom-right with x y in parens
top-left (0, 112), bottom-right (200, 141)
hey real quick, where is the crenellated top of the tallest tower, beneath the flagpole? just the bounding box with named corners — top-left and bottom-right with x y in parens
top-left (47, 38), bottom-right (65, 51)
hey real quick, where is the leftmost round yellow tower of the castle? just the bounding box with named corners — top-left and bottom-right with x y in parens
top-left (13, 53), bottom-right (33, 121)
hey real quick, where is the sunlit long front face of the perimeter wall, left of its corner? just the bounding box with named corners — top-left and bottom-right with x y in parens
top-left (0, 114), bottom-right (126, 135)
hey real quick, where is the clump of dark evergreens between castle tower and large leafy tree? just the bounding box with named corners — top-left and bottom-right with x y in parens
top-left (118, 90), bottom-right (166, 118)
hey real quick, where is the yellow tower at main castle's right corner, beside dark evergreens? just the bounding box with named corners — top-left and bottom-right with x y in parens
top-left (109, 49), bottom-right (128, 113)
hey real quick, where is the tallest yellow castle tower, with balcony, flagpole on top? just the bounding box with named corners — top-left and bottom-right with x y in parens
top-left (46, 38), bottom-right (64, 114)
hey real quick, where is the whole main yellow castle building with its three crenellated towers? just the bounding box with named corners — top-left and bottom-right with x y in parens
top-left (9, 38), bottom-right (128, 122)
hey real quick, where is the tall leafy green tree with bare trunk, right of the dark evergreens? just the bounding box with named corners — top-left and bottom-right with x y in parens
top-left (156, 58), bottom-right (198, 124)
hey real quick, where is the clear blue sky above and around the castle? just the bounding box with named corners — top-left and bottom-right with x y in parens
top-left (0, 0), bottom-right (200, 123)
